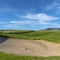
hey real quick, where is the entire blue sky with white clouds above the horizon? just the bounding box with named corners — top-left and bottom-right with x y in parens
top-left (0, 0), bottom-right (60, 30)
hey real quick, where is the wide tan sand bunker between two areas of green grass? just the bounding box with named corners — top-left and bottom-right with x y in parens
top-left (0, 39), bottom-right (60, 56)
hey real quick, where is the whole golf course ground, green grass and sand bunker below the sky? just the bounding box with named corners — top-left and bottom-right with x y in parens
top-left (0, 29), bottom-right (60, 60)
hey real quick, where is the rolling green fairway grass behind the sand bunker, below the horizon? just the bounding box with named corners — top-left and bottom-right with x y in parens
top-left (0, 30), bottom-right (60, 43)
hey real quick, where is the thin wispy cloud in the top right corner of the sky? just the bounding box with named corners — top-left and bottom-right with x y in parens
top-left (44, 0), bottom-right (60, 12)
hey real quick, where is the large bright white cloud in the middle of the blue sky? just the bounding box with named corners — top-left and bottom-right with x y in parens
top-left (20, 13), bottom-right (58, 24)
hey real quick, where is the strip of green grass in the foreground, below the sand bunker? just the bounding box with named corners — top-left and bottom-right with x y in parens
top-left (0, 53), bottom-right (60, 60)
